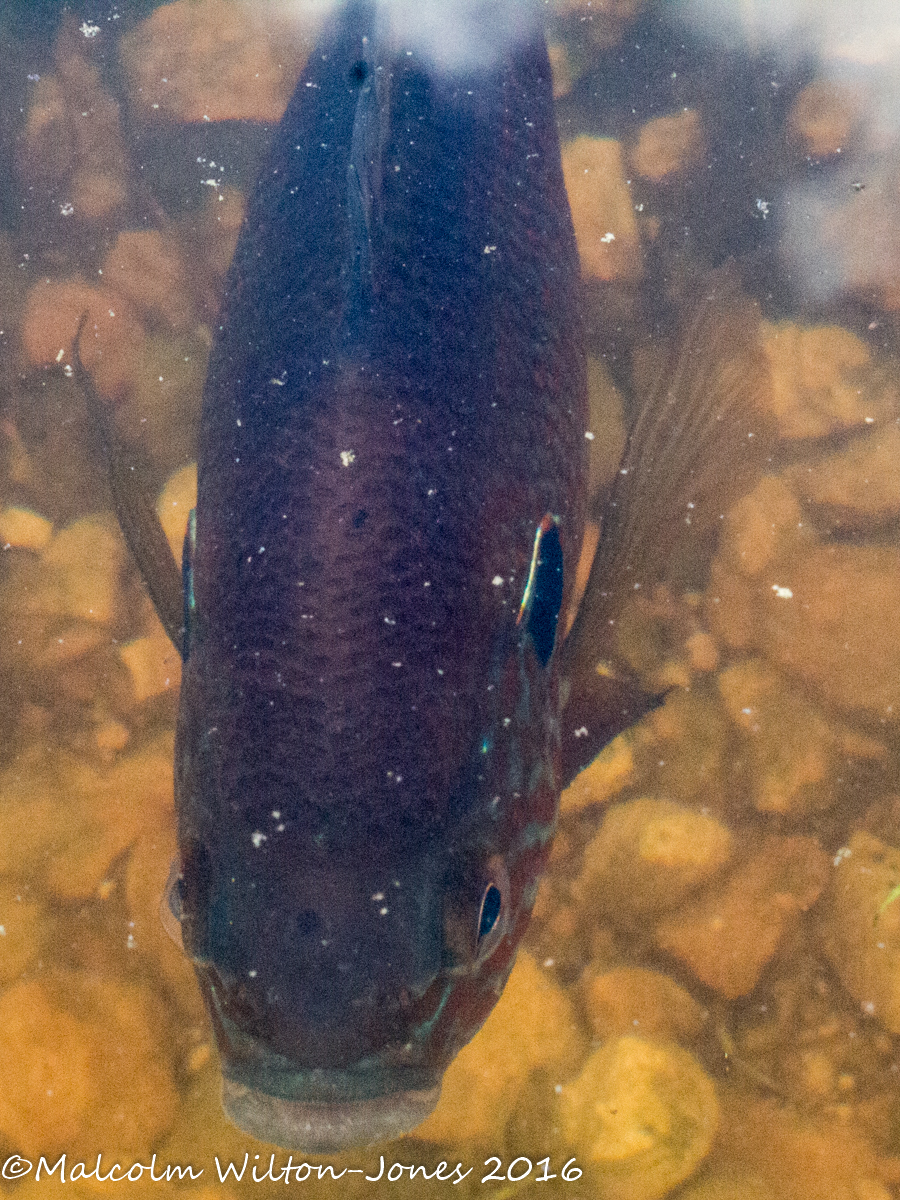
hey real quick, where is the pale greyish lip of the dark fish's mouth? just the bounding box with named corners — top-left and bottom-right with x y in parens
top-left (222, 1075), bottom-right (440, 1154)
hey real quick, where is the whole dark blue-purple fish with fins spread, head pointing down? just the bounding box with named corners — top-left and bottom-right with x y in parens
top-left (79, 4), bottom-right (777, 1152)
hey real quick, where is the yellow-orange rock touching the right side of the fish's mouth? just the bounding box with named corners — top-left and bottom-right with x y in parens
top-left (415, 950), bottom-right (584, 1145)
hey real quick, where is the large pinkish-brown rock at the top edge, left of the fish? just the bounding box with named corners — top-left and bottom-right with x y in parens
top-left (121, 0), bottom-right (305, 122)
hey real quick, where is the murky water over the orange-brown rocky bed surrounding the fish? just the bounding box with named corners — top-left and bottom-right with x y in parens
top-left (0, 0), bottom-right (900, 1200)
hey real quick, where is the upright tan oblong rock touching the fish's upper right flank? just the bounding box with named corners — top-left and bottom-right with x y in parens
top-left (563, 137), bottom-right (643, 283)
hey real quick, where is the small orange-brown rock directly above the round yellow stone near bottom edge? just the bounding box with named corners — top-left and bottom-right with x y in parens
top-left (581, 967), bottom-right (703, 1042)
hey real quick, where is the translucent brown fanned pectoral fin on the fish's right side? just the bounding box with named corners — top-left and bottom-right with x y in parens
top-left (563, 264), bottom-right (775, 758)
